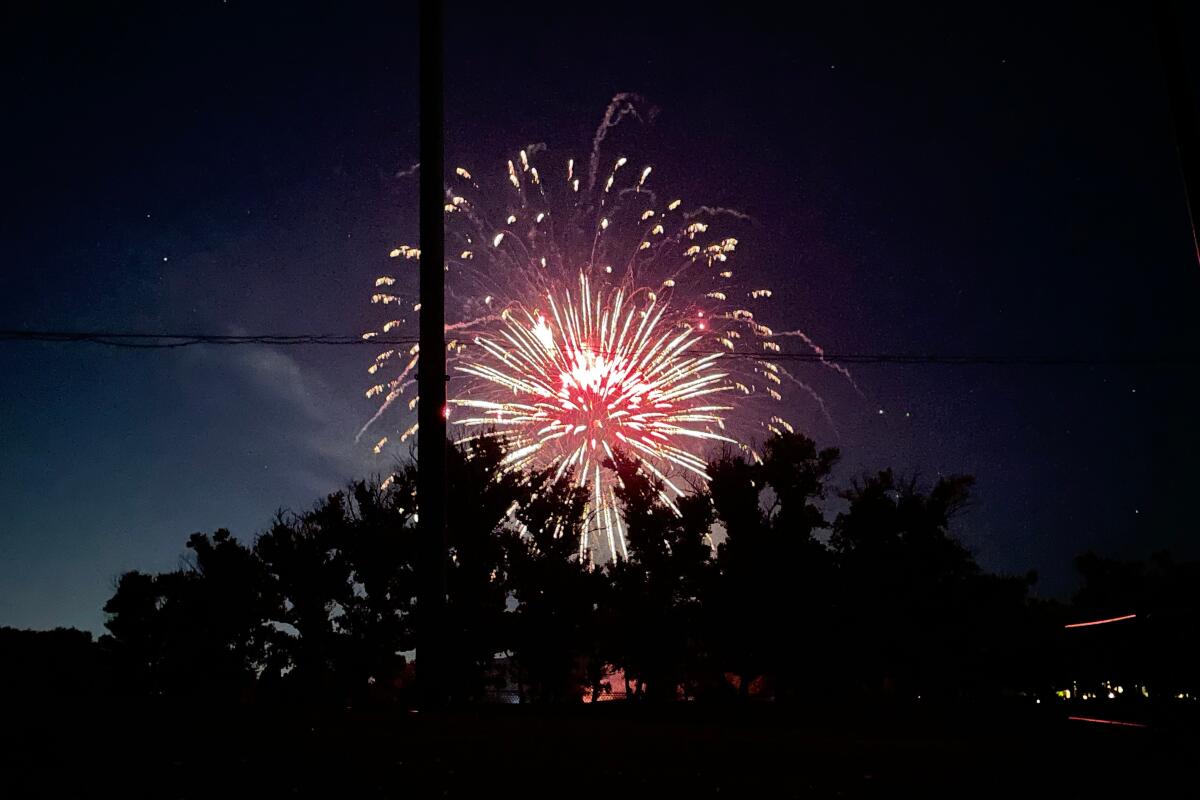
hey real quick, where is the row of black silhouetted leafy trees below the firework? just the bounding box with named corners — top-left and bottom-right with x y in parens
top-left (79, 434), bottom-right (1084, 705)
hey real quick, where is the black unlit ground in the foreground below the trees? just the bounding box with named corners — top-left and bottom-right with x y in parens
top-left (0, 700), bottom-right (1200, 800)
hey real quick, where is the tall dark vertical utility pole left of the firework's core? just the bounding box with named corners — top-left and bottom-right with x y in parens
top-left (416, 0), bottom-right (448, 709)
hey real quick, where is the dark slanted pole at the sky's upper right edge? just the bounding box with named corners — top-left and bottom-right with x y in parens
top-left (1154, 0), bottom-right (1200, 264)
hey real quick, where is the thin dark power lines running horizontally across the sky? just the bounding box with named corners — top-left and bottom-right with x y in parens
top-left (0, 330), bottom-right (1200, 367)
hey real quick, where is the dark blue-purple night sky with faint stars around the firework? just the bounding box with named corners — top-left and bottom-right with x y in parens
top-left (0, 0), bottom-right (1200, 631)
